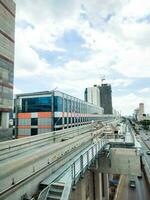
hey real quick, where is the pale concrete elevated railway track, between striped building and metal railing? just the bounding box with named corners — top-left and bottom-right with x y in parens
top-left (0, 118), bottom-right (128, 200)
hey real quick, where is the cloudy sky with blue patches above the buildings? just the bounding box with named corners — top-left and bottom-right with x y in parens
top-left (14, 0), bottom-right (150, 115)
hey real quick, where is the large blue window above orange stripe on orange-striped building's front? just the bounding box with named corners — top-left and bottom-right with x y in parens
top-left (22, 96), bottom-right (52, 112)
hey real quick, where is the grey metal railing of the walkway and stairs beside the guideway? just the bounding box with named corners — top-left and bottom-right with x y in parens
top-left (38, 138), bottom-right (107, 200)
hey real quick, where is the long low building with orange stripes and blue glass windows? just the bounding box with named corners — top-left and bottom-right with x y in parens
top-left (14, 91), bottom-right (103, 138)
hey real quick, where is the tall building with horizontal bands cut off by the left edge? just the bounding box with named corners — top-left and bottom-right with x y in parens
top-left (0, 0), bottom-right (15, 129)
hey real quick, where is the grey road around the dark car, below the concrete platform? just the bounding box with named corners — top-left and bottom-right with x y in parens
top-left (116, 174), bottom-right (150, 200)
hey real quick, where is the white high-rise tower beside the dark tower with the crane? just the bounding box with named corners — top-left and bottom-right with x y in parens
top-left (84, 85), bottom-right (100, 106)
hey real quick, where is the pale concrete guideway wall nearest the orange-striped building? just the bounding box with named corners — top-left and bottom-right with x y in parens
top-left (0, 125), bottom-right (91, 161)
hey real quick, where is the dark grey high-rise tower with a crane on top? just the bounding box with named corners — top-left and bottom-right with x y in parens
top-left (99, 84), bottom-right (113, 114)
